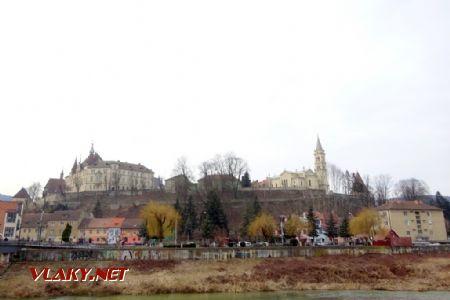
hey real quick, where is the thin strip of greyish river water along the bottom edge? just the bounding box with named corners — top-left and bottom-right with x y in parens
top-left (32, 291), bottom-right (450, 300)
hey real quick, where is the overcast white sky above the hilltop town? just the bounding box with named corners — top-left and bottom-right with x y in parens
top-left (0, 1), bottom-right (450, 195)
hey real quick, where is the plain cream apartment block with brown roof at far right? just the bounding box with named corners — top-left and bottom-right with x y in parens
top-left (377, 201), bottom-right (447, 242)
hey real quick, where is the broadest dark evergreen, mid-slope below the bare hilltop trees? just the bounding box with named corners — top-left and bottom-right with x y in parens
top-left (202, 191), bottom-right (228, 238)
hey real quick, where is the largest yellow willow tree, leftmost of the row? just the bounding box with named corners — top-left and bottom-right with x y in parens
top-left (141, 202), bottom-right (181, 240)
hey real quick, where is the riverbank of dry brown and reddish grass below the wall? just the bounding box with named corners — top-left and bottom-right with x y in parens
top-left (0, 253), bottom-right (450, 298)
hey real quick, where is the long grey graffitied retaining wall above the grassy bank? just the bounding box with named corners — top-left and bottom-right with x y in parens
top-left (11, 245), bottom-right (450, 262)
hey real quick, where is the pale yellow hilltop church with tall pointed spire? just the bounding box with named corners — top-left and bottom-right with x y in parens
top-left (268, 138), bottom-right (329, 191)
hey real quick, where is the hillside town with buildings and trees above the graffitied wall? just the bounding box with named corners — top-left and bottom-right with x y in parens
top-left (0, 138), bottom-right (450, 246)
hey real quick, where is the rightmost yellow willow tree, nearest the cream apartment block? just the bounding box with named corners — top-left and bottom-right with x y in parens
top-left (349, 208), bottom-right (386, 237)
